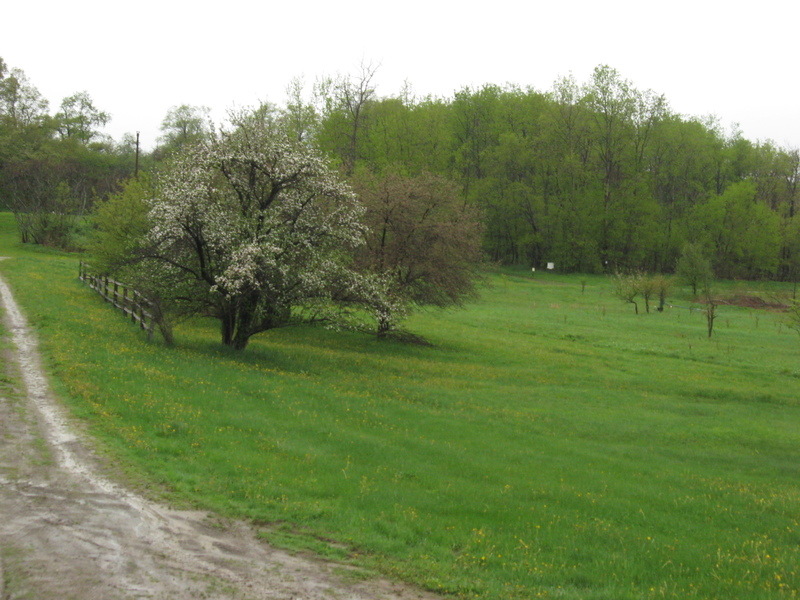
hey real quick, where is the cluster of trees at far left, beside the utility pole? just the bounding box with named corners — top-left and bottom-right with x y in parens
top-left (0, 58), bottom-right (135, 246)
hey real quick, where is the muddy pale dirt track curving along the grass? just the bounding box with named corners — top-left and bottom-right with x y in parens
top-left (0, 266), bottom-right (435, 600)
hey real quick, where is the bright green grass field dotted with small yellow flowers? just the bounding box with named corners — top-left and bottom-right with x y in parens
top-left (0, 215), bottom-right (800, 600)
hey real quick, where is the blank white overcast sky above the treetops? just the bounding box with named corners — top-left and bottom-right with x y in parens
top-left (6, 0), bottom-right (800, 148)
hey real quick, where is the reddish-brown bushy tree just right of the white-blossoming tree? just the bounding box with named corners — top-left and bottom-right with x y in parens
top-left (353, 170), bottom-right (481, 337)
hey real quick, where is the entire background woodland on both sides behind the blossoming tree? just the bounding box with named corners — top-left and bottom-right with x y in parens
top-left (0, 61), bottom-right (800, 280)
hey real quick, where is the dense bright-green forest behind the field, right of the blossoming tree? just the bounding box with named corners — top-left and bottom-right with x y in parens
top-left (315, 66), bottom-right (800, 279)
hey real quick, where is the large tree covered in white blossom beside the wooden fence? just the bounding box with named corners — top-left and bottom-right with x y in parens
top-left (136, 111), bottom-right (364, 349)
